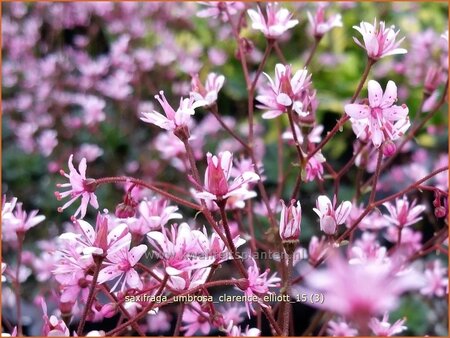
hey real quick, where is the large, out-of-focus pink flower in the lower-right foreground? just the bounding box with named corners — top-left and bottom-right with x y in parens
top-left (306, 253), bottom-right (423, 326)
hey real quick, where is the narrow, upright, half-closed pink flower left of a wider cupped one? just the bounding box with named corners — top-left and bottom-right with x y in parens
top-left (280, 200), bottom-right (302, 241)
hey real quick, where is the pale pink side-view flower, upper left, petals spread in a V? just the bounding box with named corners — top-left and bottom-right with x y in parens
top-left (141, 91), bottom-right (205, 131)
